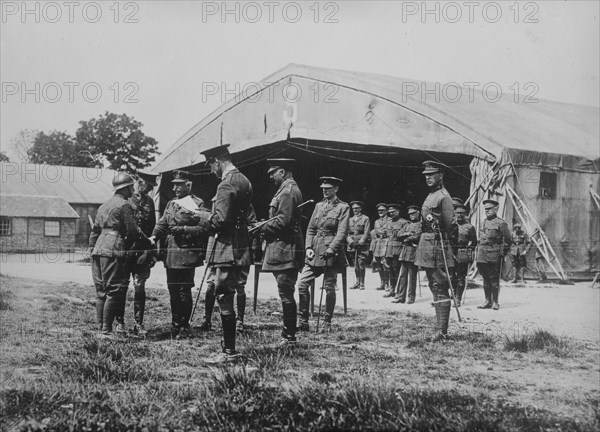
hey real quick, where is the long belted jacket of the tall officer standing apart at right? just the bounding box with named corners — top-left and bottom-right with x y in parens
top-left (415, 187), bottom-right (457, 268)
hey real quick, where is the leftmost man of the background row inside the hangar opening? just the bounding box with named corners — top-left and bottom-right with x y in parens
top-left (347, 201), bottom-right (371, 290)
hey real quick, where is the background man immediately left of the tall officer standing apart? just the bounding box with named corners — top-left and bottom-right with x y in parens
top-left (392, 206), bottom-right (421, 304)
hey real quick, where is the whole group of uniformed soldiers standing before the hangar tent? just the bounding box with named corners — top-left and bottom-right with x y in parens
top-left (90, 145), bottom-right (548, 362)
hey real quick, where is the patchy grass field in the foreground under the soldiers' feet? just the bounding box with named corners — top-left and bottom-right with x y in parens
top-left (0, 277), bottom-right (600, 431)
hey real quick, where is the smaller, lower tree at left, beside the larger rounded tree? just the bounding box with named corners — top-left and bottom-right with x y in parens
top-left (27, 131), bottom-right (95, 166)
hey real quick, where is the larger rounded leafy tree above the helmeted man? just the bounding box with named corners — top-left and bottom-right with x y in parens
top-left (75, 111), bottom-right (159, 171)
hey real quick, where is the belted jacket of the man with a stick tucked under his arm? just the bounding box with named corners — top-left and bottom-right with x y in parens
top-left (261, 179), bottom-right (304, 271)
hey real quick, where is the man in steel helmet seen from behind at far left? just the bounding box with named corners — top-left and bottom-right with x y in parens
top-left (89, 172), bottom-right (152, 337)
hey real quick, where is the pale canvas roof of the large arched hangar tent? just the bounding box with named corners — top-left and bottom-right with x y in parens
top-left (154, 64), bottom-right (600, 172)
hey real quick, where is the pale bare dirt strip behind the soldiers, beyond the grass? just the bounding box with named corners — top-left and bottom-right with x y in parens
top-left (0, 254), bottom-right (600, 344)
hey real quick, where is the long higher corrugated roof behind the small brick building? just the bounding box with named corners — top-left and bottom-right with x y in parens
top-left (0, 162), bottom-right (116, 204)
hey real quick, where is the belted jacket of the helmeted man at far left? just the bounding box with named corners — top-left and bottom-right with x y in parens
top-left (89, 194), bottom-right (150, 259)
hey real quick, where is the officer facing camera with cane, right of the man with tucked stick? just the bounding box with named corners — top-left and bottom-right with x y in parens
top-left (298, 177), bottom-right (350, 331)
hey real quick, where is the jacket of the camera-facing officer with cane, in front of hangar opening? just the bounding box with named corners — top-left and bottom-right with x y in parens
top-left (305, 198), bottom-right (350, 267)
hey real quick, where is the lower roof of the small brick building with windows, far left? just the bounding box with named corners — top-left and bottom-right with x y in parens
top-left (0, 194), bottom-right (79, 219)
